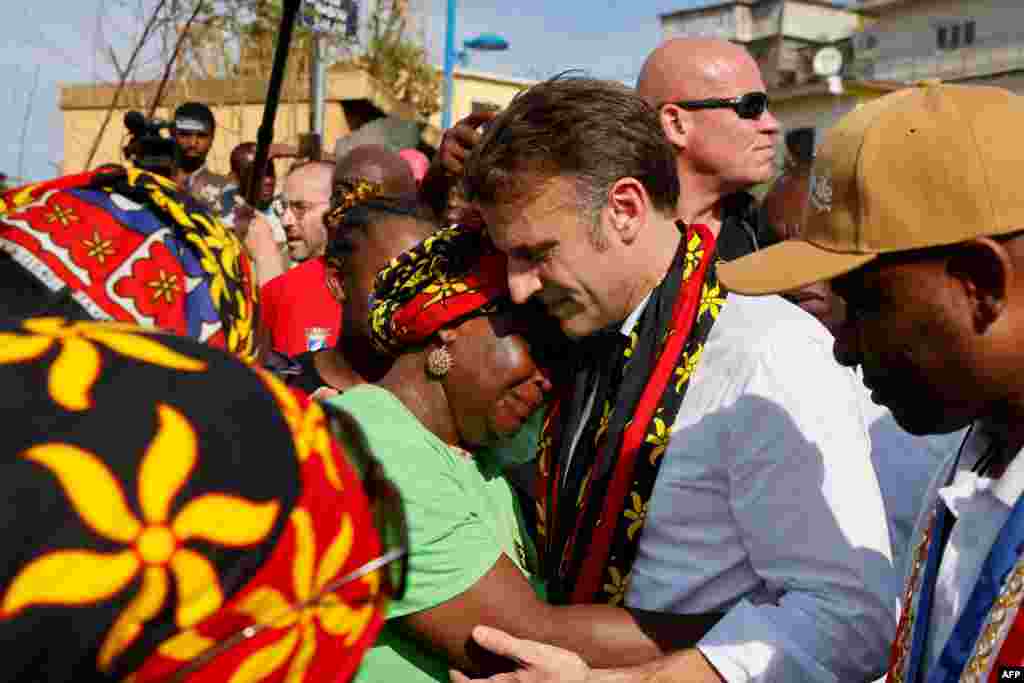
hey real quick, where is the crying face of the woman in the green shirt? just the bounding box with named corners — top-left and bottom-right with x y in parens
top-left (444, 310), bottom-right (551, 447)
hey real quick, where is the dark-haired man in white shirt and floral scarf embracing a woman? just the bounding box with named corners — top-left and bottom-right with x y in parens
top-left (456, 74), bottom-right (895, 683)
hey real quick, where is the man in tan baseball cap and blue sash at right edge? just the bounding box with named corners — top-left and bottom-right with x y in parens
top-left (721, 85), bottom-right (1024, 681)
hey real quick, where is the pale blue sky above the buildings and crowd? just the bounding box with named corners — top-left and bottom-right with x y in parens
top-left (0, 0), bottom-right (703, 184)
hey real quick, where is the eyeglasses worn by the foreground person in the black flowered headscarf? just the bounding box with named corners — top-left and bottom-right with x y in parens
top-left (152, 402), bottom-right (409, 683)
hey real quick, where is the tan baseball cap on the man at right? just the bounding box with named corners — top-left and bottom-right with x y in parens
top-left (718, 84), bottom-right (1024, 294)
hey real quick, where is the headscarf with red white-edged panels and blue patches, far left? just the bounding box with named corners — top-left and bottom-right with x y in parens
top-left (0, 166), bottom-right (258, 361)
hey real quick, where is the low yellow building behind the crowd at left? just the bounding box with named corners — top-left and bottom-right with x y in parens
top-left (59, 65), bottom-right (532, 173)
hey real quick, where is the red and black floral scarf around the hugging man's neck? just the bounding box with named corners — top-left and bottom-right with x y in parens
top-left (537, 223), bottom-right (726, 605)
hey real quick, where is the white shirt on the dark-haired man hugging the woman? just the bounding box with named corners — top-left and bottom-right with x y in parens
top-left (626, 294), bottom-right (896, 683)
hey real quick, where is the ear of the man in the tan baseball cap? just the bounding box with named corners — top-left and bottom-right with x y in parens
top-left (946, 238), bottom-right (1016, 334)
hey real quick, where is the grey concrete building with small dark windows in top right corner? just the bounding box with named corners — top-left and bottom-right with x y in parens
top-left (851, 0), bottom-right (1024, 92)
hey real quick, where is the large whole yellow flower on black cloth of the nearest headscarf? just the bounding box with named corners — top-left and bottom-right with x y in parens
top-left (0, 403), bottom-right (280, 671)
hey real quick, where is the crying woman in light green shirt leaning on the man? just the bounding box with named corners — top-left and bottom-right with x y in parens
top-left (319, 209), bottom-right (712, 683)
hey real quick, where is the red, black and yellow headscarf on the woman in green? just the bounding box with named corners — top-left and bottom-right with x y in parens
top-left (370, 225), bottom-right (509, 354)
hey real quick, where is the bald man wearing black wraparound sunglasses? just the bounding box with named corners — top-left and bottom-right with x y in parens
top-left (637, 38), bottom-right (779, 260)
